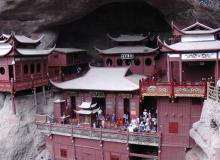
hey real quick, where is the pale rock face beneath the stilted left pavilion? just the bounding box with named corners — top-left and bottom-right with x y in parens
top-left (0, 94), bottom-right (52, 160)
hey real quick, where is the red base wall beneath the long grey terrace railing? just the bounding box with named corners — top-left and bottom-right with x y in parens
top-left (45, 135), bottom-right (129, 160)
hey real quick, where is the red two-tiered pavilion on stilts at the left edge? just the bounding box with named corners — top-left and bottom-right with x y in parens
top-left (0, 33), bottom-right (53, 113)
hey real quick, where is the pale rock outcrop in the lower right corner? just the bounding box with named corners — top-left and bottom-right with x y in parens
top-left (187, 99), bottom-right (220, 160)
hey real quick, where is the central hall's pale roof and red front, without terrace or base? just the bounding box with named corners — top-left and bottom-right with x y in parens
top-left (51, 67), bottom-right (145, 121)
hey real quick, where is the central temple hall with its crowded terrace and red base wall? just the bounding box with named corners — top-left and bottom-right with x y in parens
top-left (36, 66), bottom-right (160, 160)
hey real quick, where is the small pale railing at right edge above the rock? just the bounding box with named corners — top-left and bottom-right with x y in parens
top-left (207, 83), bottom-right (220, 103)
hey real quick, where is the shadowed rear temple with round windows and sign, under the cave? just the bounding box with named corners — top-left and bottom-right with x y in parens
top-left (96, 34), bottom-right (158, 76)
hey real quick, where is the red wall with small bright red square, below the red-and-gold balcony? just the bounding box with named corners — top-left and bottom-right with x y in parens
top-left (157, 97), bottom-right (202, 160)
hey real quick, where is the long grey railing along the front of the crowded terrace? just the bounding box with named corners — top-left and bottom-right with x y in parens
top-left (36, 115), bottom-right (161, 147)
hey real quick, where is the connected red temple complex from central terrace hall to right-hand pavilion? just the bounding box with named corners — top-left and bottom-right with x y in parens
top-left (36, 22), bottom-right (220, 160)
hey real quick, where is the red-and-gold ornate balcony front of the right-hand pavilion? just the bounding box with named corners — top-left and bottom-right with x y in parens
top-left (140, 81), bottom-right (207, 98)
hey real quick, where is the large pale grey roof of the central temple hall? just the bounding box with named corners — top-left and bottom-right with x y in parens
top-left (51, 67), bottom-right (143, 91)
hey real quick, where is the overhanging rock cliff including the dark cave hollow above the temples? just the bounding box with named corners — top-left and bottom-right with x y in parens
top-left (0, 0), bottom-right (220, 52)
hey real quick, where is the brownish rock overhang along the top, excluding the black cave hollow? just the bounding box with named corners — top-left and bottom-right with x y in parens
top-left (0, 0), bottom-right (220, 33)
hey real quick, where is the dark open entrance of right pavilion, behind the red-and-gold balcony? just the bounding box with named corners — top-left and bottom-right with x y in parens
top-left (182, 61), bottom-right (215, 82)
